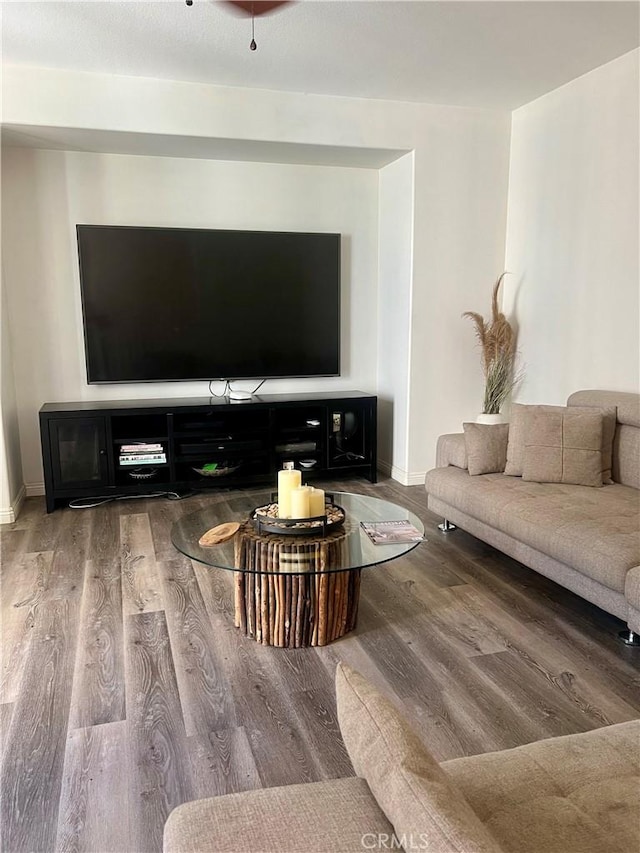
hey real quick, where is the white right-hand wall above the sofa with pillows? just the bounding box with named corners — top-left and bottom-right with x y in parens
top-left (505, 50), bottom-right (640, 403)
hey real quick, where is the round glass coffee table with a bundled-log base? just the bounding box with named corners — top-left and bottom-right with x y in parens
top-left (171, 492), bottom-right (424, 648)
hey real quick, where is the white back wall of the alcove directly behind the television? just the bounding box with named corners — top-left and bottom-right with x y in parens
top-left (2, 149), bottom-right (378, 492)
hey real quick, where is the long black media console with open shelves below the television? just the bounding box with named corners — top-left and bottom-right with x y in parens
top-left (40, 391), bottom-right (377, 512)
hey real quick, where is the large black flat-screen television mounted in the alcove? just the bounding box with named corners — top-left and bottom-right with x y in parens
top-left (77, 225), bottom-right (340, 384)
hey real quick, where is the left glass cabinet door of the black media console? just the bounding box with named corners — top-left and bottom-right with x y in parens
top-left (49, 417), bottom-right (109, 489)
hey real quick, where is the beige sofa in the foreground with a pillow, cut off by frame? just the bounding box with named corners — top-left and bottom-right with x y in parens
top-left (164, 664), bottom-right (640, 853)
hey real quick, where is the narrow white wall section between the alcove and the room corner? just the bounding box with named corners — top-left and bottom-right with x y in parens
top-left (407, 111), bottom-right (509, 485)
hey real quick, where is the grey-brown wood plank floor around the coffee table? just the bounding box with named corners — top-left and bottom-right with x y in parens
top-left (0, 480), bottom-right (640, 853)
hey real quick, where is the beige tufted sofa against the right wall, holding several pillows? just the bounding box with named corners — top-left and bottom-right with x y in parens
top-left (425, 391), bottom-right (640, 644)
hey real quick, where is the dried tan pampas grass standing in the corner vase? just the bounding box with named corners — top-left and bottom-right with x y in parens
top-left (462, 272), bottom-right (522, 415)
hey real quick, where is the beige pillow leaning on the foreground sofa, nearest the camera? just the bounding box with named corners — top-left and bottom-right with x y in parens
top-left (336, 663), bottom-right (501, 853)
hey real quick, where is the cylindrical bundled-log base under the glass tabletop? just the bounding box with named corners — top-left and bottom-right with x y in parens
top-left (235, 525), bottom-right (362, 648)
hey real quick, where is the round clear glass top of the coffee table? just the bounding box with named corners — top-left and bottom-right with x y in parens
top-left (171, 492), bottom-right (424, 575)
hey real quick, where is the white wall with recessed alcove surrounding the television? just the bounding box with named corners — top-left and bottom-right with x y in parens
top-left (3, 68), bottom-right (509, 512)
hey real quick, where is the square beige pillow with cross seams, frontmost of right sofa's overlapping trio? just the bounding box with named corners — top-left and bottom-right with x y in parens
top-left (522, 408), bottom-right (602, 486)
